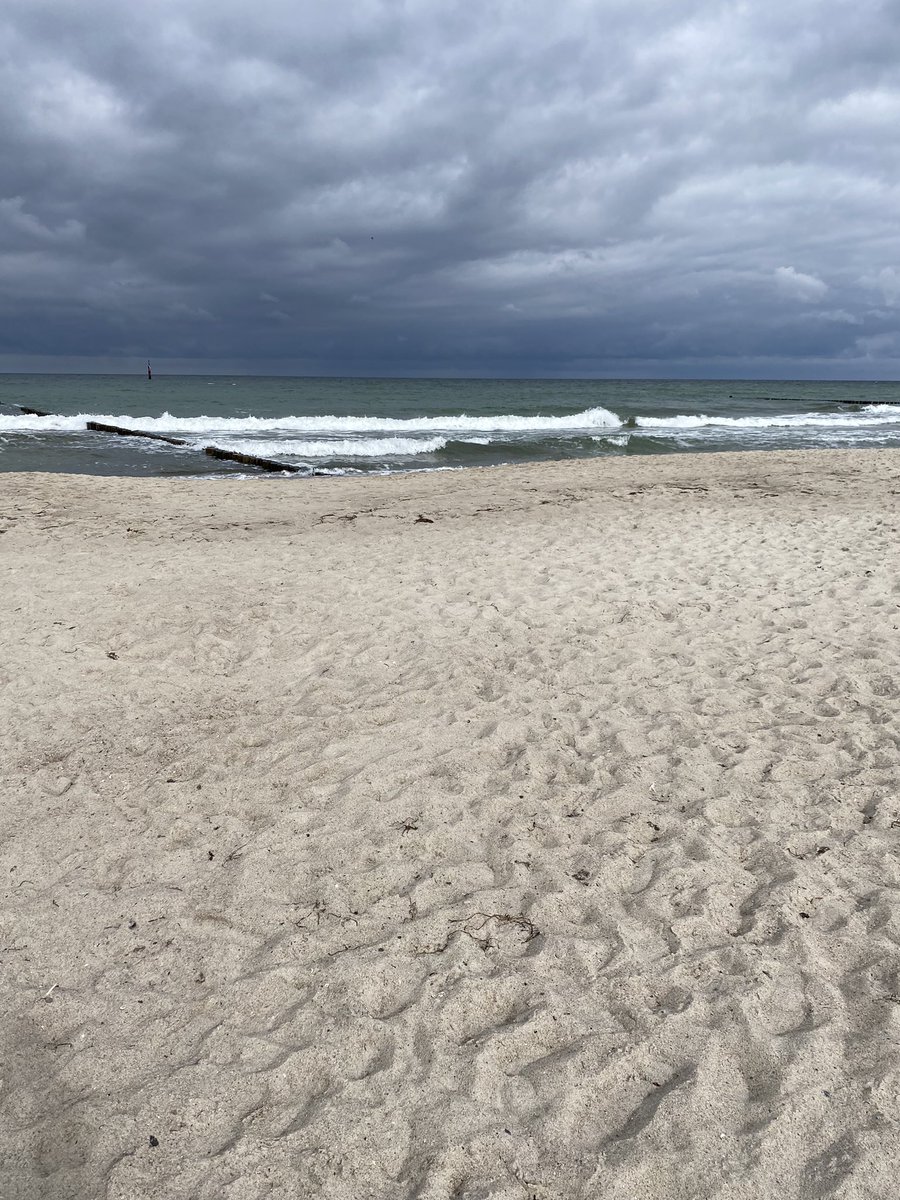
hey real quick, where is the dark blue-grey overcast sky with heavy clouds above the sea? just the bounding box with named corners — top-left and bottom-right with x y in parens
top-left (0, 0), bottom-right (900, 379)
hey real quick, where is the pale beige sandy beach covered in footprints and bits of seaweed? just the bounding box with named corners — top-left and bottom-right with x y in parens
top-left (0, 451), bottom-right (900, 1200)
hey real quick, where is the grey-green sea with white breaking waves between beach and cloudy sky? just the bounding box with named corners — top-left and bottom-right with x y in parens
top-left (0, 374), bottom-right (900, 479)
